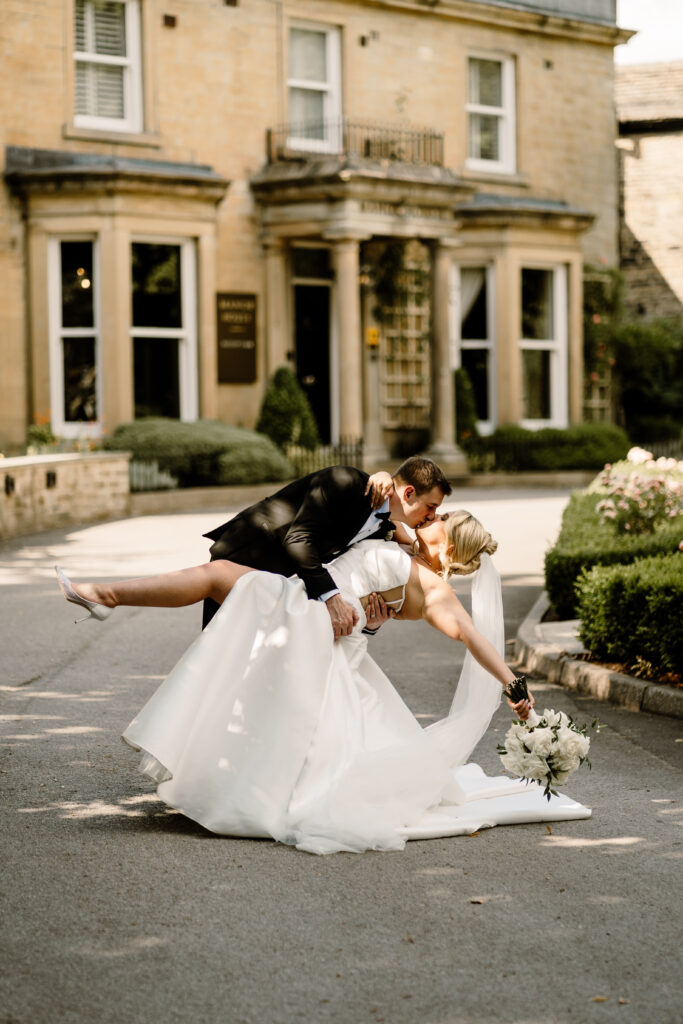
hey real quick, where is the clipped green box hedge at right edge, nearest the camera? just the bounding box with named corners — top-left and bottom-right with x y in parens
top-left (577, 553), bottom-right (683, 673)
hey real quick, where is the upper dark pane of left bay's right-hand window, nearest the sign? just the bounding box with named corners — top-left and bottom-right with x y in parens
top-left (131, 242), bottom-right (182, 328)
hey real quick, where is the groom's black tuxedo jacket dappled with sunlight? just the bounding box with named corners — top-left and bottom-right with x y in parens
top-left (204, 466), bottom-right (391, 598)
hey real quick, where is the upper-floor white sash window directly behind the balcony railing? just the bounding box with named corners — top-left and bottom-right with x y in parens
top-left (287, 24), bottom-right (342, 153)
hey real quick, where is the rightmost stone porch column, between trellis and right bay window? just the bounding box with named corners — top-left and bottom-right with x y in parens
top-left (427, 241), bottom-right (467, 473)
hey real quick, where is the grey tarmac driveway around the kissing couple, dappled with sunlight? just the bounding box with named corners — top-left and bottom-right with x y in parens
top-left (0, 488), bottom-right (683, 1024)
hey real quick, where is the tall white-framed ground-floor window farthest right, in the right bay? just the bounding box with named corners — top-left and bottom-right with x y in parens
top-left (519, 266), bottom-right (568, 427)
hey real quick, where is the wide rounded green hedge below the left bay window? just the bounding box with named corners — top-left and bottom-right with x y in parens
top-left (109, 417), bottom-right (295, 487)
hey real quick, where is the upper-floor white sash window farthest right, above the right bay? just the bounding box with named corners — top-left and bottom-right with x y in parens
top-left (467, 55), bottom-right (516, 174)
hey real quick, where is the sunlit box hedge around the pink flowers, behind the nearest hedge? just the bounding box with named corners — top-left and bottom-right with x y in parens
top-left (546, 492), bottom-right (681, 618)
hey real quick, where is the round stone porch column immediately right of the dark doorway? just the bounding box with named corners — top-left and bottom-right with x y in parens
top-left (332, 239), bottom-right (364, 437)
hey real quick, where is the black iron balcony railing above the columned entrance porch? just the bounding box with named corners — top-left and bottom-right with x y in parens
top-left (267, 118), bottom-right (443, 167)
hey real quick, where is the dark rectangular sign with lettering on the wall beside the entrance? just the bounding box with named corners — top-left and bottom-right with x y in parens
top-left (216, 292), bottom-right (256, 384)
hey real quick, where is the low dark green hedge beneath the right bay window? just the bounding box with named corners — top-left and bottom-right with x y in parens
top-left (480, 423), bottom-right (630, 472)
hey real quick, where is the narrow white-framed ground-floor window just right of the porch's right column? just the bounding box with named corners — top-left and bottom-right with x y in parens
top-left (459, 266), bottom-right (496, 434)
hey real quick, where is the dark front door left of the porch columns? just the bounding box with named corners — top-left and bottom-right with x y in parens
top-left (294, 285), bottom-right (330, 444)
